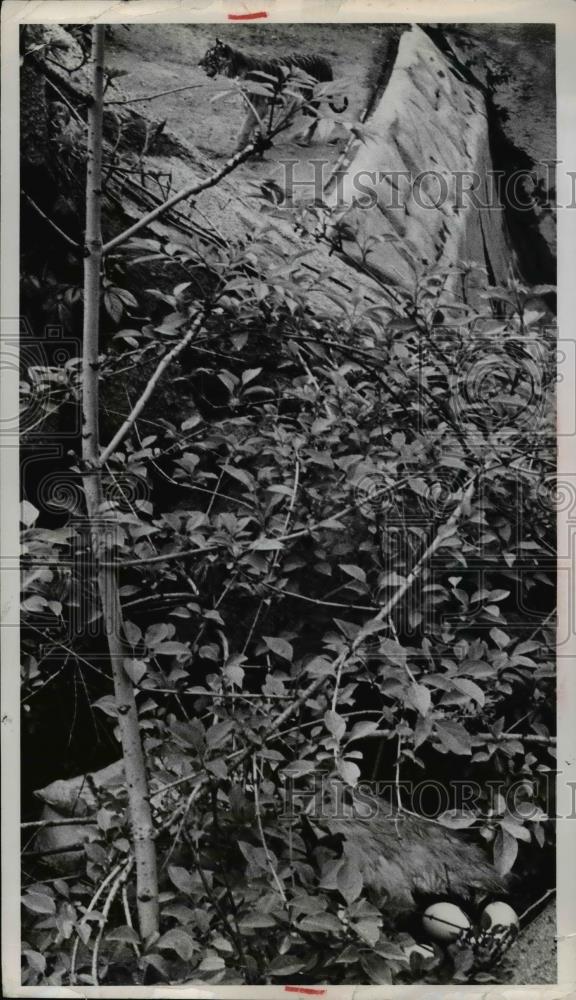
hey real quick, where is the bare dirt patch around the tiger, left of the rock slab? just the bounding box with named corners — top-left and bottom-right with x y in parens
top-left (108, 24), bottom-right (391, 195)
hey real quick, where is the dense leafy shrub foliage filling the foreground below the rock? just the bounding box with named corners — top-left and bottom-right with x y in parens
top-left (23, 227), bottom-right (555, 983)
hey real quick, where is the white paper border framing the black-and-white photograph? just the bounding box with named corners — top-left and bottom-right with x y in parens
top-left (0, 0), bottom-right (576, 1000)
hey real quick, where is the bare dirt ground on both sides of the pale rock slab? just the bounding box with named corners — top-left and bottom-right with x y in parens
top-left (108, 24), bottom-right (556, 253)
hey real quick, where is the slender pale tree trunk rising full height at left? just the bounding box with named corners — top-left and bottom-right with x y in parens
top-left (82, 25), bottom-right (158, 939)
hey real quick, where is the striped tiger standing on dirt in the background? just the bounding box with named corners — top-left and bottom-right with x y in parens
top-left (198, 38), bottom-right (348, 152)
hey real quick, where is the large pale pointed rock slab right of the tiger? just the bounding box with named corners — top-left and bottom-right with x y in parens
top-left (329, 26), bottom-right (512, 300)
